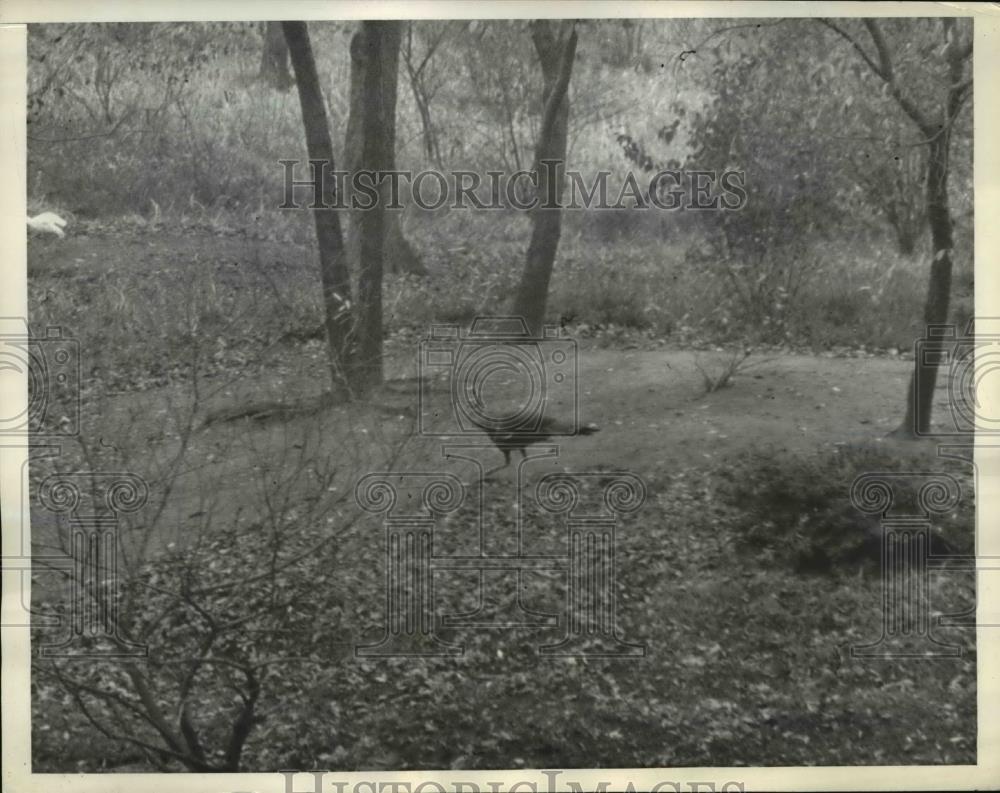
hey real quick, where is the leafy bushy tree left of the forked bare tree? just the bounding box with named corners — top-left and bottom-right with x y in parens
top-left (676, 25), bottom-right (844, 342)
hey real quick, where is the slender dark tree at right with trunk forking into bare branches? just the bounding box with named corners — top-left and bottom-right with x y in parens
top-left (820, 17), bottom-right (972, 435)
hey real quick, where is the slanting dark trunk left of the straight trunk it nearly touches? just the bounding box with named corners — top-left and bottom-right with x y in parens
top-left (281, 22), bottom-right (351, 393)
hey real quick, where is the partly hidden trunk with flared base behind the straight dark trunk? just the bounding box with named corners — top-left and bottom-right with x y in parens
top-left (344, 25), bottom-right (427, 275)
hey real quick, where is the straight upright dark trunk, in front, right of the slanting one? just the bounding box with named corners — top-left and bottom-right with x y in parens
top-left (351, 22), bottom-right (402, 390)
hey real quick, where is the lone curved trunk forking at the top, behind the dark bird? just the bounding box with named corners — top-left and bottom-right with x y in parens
top-left (514, 20), bottom-right (576, 336)
